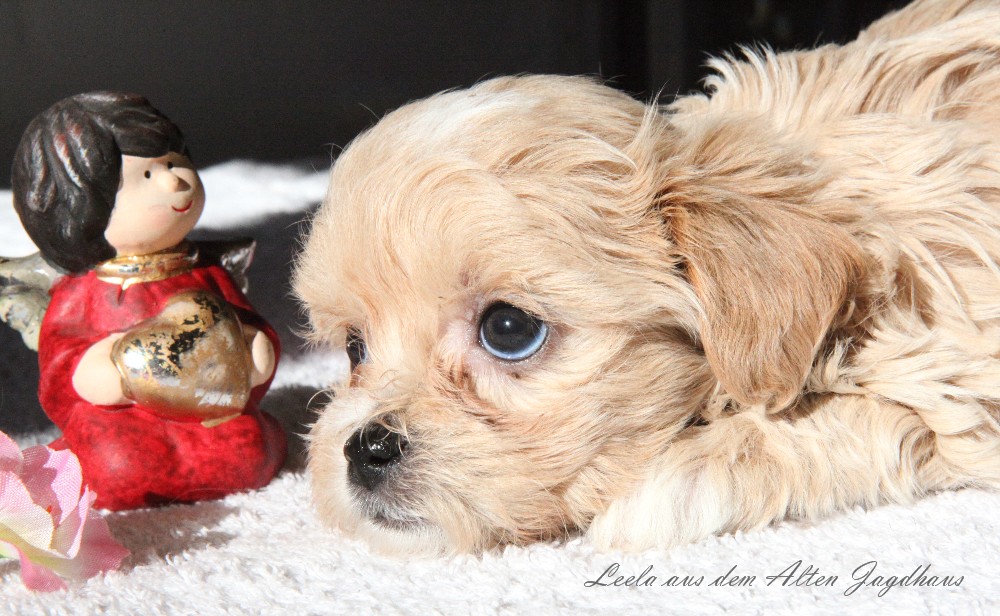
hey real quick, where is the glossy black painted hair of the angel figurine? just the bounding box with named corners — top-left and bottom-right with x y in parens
top-left (11, 92), bottom-right (188, 273)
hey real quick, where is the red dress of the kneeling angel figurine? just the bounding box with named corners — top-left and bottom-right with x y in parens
top-left (38, 265), bottom-right (287, 509)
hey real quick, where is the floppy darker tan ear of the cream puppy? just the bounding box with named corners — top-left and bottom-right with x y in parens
top-left (661, 121), bottom-right (865, 411)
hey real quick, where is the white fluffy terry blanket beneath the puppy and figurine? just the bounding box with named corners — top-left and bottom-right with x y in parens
top-left (0, 163), bottom-right (1000, 616)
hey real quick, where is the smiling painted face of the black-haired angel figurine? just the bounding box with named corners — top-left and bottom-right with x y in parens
top-left (104, 152), bottom-right (205, 257)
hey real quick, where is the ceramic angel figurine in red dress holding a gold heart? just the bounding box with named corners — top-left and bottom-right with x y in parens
top-left (0, 92), bottom-right (286, 509)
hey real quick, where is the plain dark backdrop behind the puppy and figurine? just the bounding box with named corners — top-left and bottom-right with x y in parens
top-left (0, 0), bottom-right (904, 434)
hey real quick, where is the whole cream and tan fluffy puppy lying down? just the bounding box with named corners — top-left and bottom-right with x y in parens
top-left (294, 0), bottom-right (1000, 553)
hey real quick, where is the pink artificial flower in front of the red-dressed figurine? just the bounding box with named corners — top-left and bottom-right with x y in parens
top-left (0, 432), bottom-right (128, 591)
